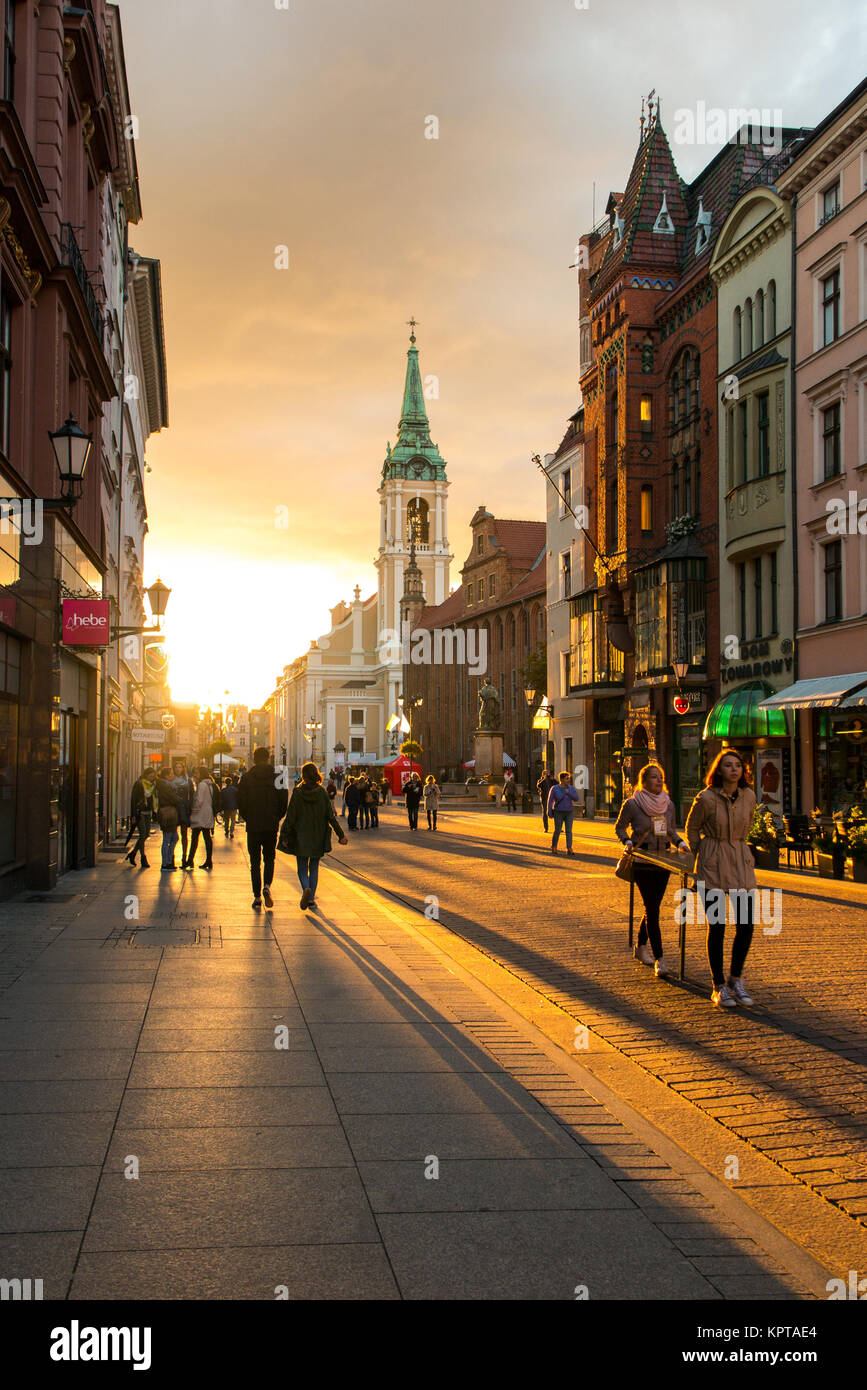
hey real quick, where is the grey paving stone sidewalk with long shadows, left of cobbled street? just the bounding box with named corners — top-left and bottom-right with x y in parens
top-left (0, 842), bottom-right (810, 1300)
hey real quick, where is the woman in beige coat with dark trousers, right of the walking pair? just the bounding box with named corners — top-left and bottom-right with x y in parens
top-left (685, 748), bottom-right (756, 1009)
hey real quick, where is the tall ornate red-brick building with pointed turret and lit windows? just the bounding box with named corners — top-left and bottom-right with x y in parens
top-left (568, 97), bottom-right (793, 816)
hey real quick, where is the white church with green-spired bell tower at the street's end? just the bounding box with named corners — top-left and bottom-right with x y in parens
top-left (265, 332), bottom-right (453, 771)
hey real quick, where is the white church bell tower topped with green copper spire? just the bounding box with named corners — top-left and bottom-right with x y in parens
top-left (374, 320), bottom-right (453, 644)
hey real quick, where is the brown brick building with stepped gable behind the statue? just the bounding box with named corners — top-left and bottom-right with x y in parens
top-left (402, 506), bottom-right (546, 783)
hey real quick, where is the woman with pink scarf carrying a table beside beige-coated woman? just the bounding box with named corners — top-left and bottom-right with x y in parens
top-left (614, 763), bottom-right (689, 980)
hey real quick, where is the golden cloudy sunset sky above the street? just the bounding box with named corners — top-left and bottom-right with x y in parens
top-left (119, 0), bottom-right (866, 706)
